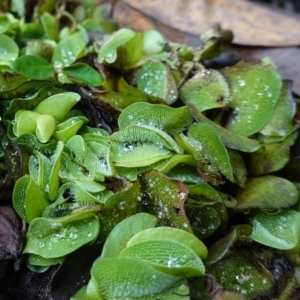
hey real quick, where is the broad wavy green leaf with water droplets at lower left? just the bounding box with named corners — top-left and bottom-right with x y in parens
top-left (23, 211), bottom-right (99, 258)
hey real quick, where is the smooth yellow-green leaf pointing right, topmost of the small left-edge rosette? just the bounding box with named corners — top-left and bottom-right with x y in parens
top-left (34, 92), bottom-right (80, 122)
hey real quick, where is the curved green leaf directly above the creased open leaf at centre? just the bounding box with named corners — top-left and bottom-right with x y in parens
top-left (118, 102), bottom-right (193, 134)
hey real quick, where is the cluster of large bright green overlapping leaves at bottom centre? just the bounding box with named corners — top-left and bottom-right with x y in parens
top-left (75, 213), bottom-right (207, 300)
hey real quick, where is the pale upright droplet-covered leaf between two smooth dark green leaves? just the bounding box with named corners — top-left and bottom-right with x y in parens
top-left (52, 32), bottom-right (86, 70)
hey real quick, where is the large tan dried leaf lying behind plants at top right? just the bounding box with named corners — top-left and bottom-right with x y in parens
top-left (123, 0), bottom-right (300, 46)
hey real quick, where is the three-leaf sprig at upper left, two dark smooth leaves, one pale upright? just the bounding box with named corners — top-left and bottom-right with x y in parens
top-left (9, 27), bottom-right (103, 86)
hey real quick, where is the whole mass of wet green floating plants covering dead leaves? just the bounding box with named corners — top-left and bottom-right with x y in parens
top-left (0, 1), bottom-right (300, 300)
